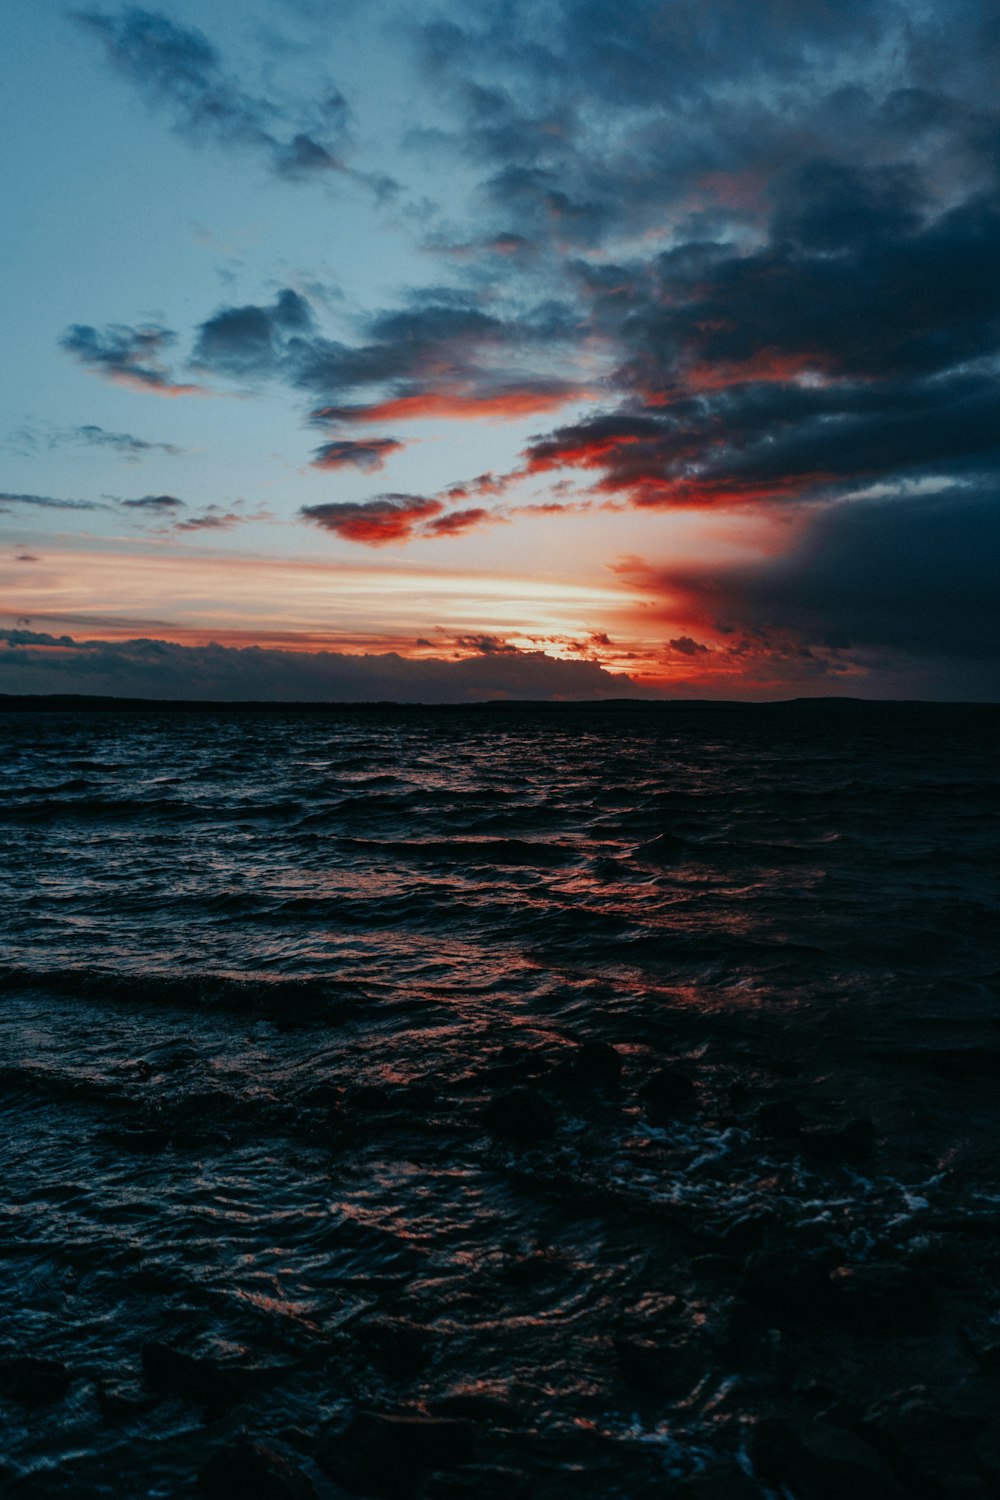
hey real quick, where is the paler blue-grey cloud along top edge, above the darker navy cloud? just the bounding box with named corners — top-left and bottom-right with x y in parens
top-left (412, 0), bottom-right (1000, 279)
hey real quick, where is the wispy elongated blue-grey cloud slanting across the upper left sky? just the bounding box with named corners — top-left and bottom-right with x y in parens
top-left (73, 6), bottom-right (348, 177)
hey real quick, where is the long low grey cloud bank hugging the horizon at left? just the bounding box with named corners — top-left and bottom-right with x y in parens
top-left (0, 630), bottom-right (658, 704)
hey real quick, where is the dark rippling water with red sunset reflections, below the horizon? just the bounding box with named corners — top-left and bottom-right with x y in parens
top-left (0, 705), bottom-right (1000, 1500)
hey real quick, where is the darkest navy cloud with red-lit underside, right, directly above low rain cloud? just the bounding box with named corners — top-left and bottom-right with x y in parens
top-left (526, 173), bottom-right (1000, 506)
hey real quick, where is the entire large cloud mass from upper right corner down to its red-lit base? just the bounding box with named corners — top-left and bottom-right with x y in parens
top-left (398, 0), bottom-right (1000, 543)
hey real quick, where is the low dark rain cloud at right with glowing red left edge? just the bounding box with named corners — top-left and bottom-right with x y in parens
top-left (615, 486), bottom-right (1000, 698)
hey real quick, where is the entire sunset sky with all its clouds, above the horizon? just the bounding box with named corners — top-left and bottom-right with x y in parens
top-left (0, 0), bottom-right (1000, 702)
